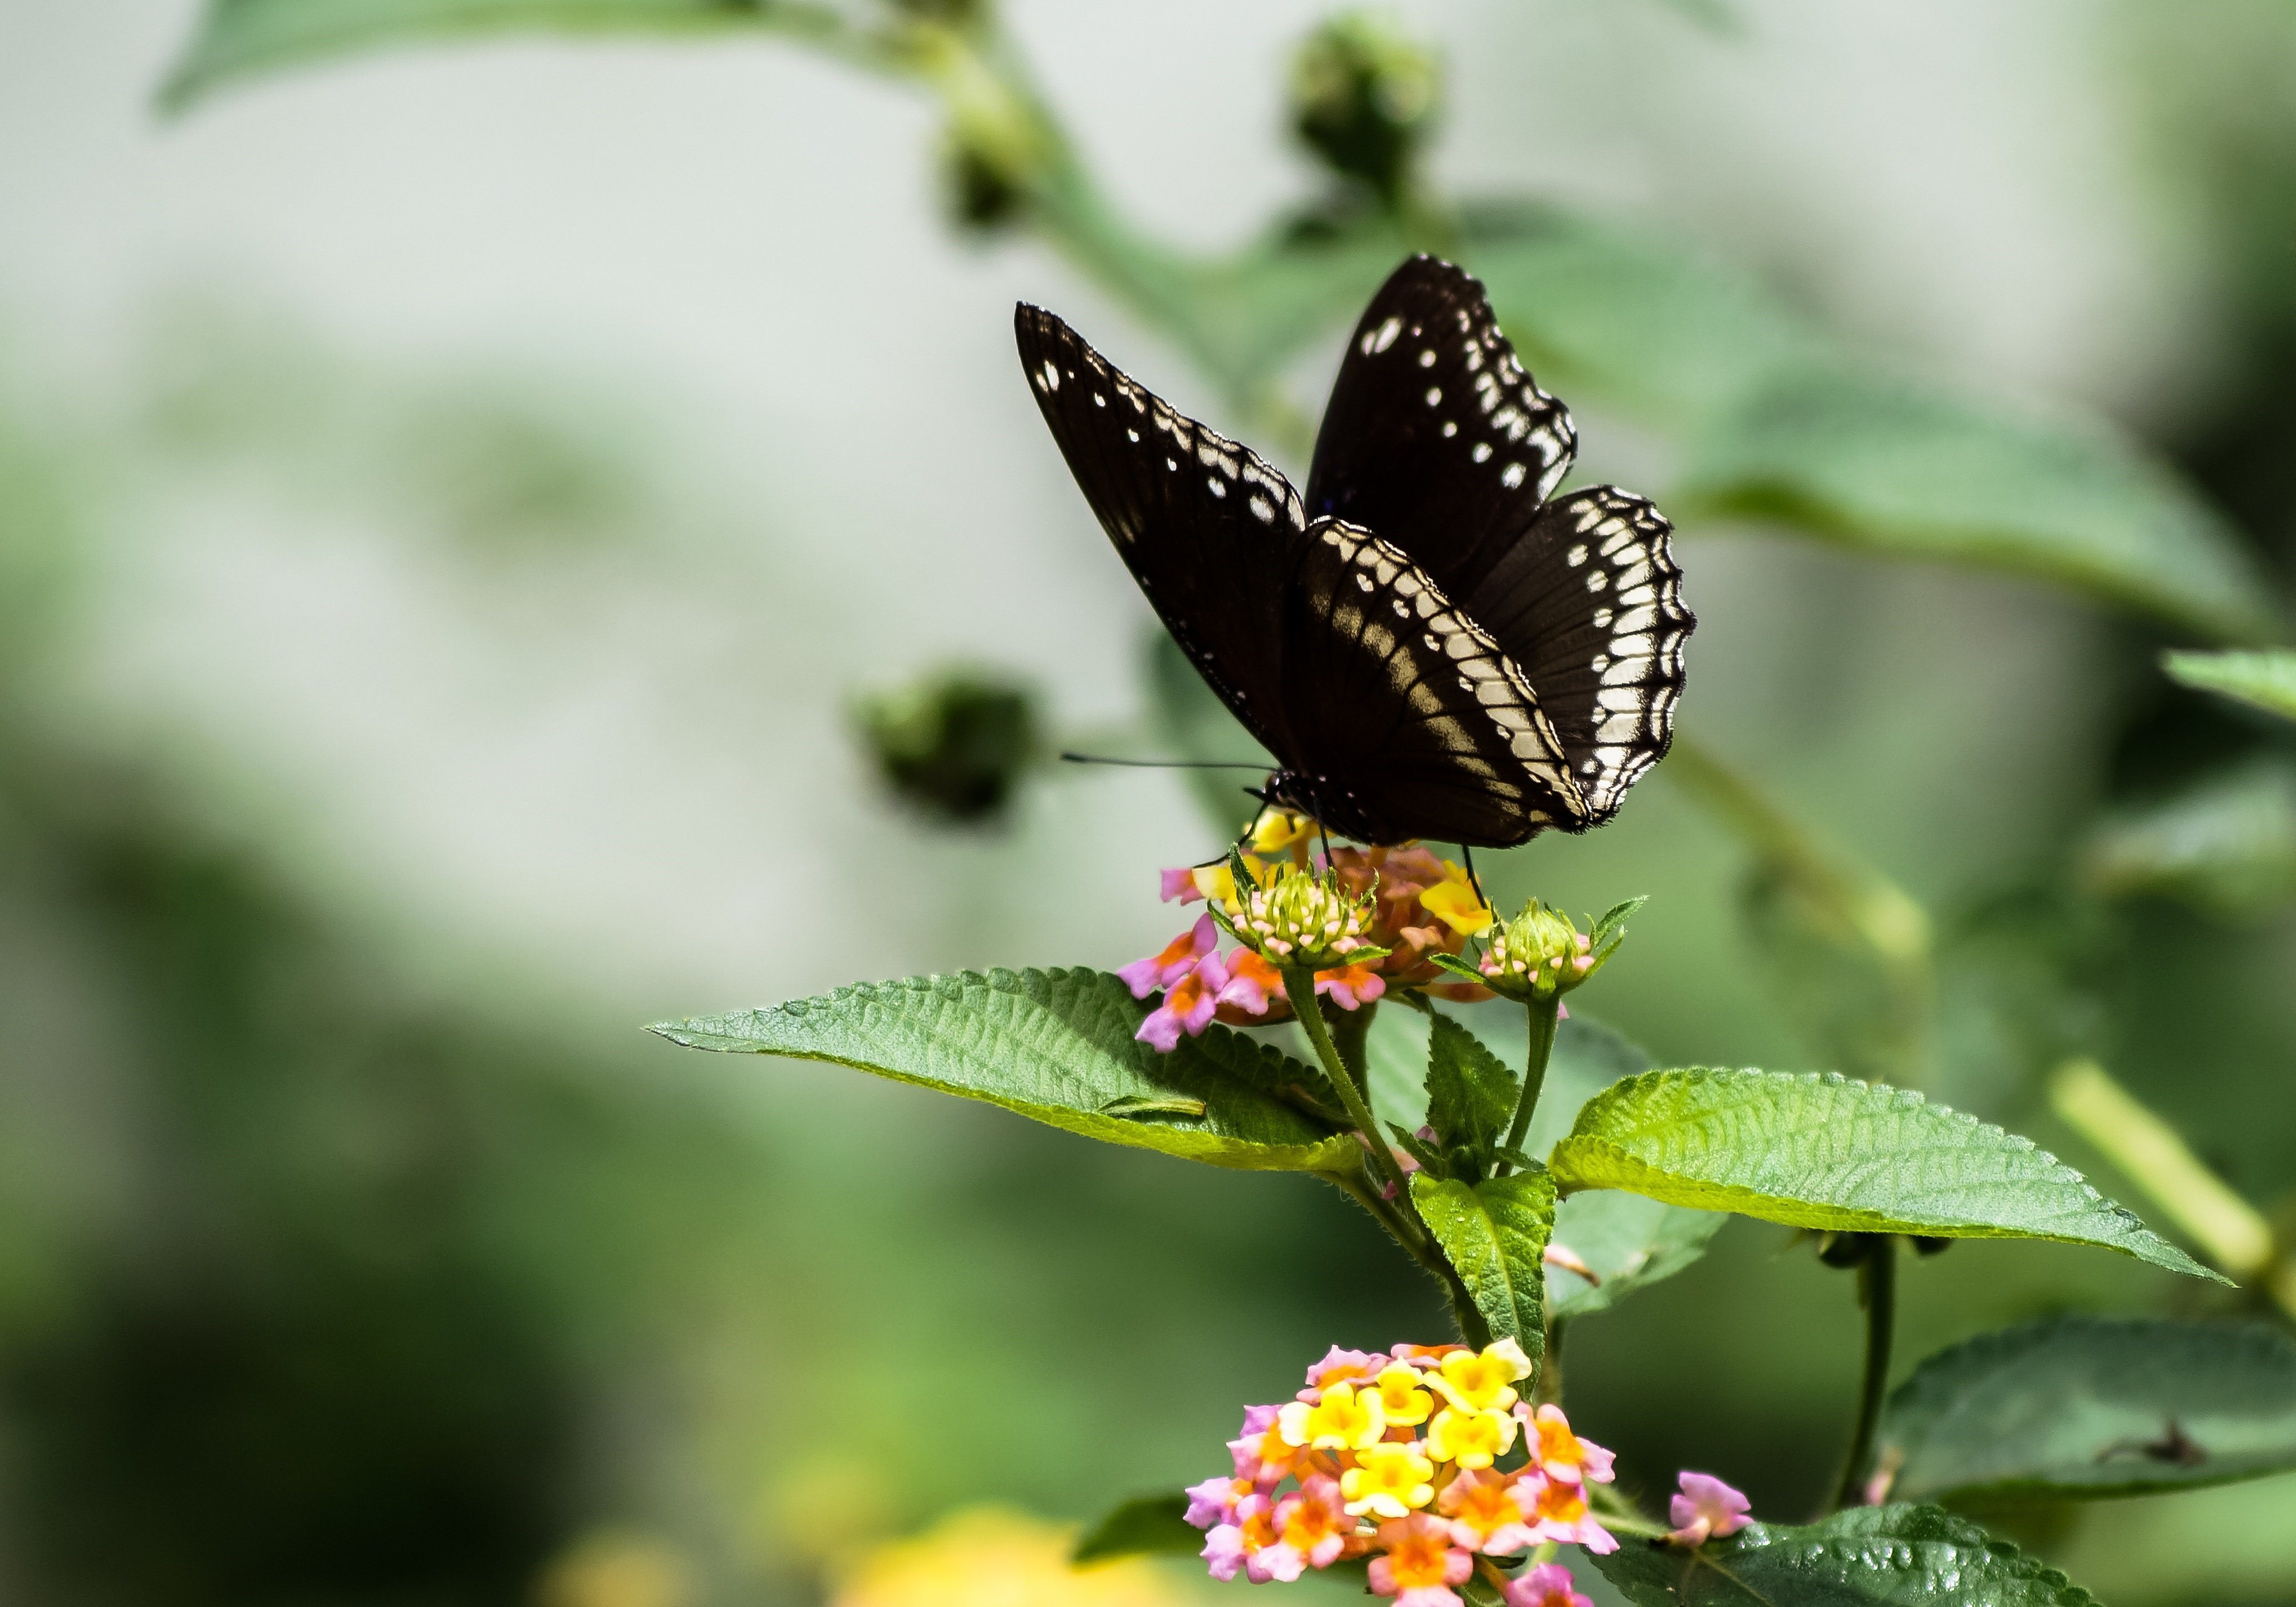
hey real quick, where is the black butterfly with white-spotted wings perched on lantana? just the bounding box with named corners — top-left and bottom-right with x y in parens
top-left (1015, 257), bottom-right (1697, 847)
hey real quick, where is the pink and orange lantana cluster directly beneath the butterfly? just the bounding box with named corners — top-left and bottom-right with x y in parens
top-left (1118, 810), bottom-right (1492, 1054)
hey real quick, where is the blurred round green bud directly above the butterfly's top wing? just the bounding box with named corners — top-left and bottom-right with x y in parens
top-left (1290, 12), bottom-right (1442, 209)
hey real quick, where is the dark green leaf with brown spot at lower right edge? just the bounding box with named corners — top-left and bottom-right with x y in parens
top-left (1880, 1315), bottom-right (2296, 1501)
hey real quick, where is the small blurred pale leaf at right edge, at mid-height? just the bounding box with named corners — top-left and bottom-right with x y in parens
top-left (2080, 760), bottom-right (2296, 916)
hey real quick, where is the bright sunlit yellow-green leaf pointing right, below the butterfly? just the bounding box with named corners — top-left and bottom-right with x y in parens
top-left (1547, 1067), bottom-right (2223, 1281)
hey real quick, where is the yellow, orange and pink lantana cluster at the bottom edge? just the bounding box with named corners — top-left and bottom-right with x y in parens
top-left (1187, 1338), bottom-right (1616, 1607)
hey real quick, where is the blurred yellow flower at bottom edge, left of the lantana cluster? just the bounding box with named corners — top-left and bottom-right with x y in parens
top-left (831, 1506), bottom-right (1194, 1607)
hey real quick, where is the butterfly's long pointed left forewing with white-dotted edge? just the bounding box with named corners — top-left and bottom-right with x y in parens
top-left (1012, 303), bottom-right (1306, 769)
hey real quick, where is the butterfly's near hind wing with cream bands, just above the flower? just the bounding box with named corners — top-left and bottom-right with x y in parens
top-left (1286, 519), bottom-right (1586, 847)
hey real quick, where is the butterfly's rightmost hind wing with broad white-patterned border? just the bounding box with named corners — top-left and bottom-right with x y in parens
top-left (1463, 485), bottom-right (1697, 831)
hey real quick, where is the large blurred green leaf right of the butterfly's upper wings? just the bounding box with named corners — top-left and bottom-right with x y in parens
top-left (1669, 363), bottom-right (2284, 640)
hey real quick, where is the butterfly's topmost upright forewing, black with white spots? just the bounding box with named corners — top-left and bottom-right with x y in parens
top-left (1306, 257), bottom-right (1577, 597)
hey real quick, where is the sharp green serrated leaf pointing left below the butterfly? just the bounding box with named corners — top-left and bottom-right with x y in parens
top-left (652, 971), bottom-right (1361, 1171)
